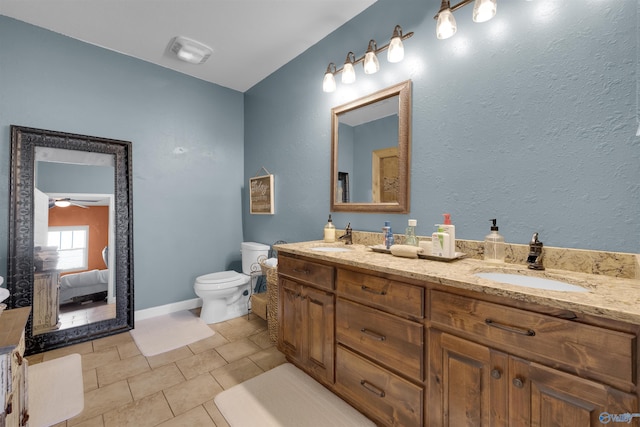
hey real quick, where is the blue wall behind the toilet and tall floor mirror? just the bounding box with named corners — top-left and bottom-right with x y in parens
top-left (0, 16), bottom-right (244, 310)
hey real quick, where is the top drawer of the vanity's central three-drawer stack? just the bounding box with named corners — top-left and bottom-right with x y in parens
top-left (337, 269), bottom-right (424, 319)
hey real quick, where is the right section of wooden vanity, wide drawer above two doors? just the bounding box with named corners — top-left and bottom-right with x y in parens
top-left (426, 291), bottom-right (638, 427)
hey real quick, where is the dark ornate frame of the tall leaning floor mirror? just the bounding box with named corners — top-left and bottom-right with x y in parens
top-left (7, 125), bottom-right (134, 355)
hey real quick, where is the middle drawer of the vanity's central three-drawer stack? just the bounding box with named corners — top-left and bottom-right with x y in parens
top-left (336, 298), bottom-right (424, 381)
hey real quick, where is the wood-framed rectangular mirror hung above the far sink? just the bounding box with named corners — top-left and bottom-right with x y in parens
top-left (331, 80), bottom-right (411, 214)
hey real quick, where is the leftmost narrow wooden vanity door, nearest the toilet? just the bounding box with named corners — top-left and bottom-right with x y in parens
top-left (278, 278), bottom-right (303, 362)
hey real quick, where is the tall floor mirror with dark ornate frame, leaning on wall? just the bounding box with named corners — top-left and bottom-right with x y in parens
top-left (7, 125), bottom-right (134, 355)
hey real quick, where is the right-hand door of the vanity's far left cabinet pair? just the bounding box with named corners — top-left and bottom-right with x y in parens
top-left (303, 287), bottom-right (335, 384)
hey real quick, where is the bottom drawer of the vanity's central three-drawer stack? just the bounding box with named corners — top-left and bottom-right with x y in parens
top-left (336, 345), bottom-right (424, 426)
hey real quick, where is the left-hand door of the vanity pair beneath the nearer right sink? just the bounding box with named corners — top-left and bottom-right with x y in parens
top-left (425, 329), bottom-right (509, 427)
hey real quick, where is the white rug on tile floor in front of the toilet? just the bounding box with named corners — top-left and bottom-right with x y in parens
top-left (130, 310), bottom-right (214, 357)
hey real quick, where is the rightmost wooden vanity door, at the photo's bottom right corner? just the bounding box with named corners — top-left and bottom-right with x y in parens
top-left (509, 357), bottom-right (639, 427)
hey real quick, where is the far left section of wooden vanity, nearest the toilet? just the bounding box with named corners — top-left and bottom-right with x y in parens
top-left (278, 256), bottom-right (335, 385)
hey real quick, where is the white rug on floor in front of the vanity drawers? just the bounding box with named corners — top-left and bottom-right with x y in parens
top-left (215, 363), bottom-right (375, 427)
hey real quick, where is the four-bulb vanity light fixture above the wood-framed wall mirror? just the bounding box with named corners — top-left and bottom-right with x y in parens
top-left (322, 25), bottom-right (413, 92)
